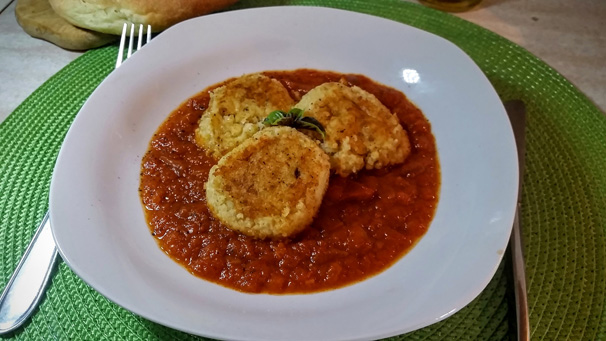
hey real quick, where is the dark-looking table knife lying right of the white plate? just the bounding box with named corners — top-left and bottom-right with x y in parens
top-left (504, 100), bottom-right (530, 341)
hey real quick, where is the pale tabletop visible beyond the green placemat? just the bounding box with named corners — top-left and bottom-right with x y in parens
top-left (0, 0), bottom-right (606, 122)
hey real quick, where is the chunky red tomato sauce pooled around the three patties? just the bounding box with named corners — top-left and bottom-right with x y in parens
top-left (139, 69), bottom-right (440, 294)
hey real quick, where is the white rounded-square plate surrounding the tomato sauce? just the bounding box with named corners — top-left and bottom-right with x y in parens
top-left (50, 7), bottom-right (518, 340)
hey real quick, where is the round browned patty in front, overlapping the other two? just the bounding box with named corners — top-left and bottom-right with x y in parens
top-left (206, 127), bottom-right (330, 238)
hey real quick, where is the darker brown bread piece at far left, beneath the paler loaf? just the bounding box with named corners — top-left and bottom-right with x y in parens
top-left (15, 0), bottom-right (118, 50)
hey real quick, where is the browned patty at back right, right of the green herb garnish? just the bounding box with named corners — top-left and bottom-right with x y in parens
top-left (295, 82), bottom-right (410, 176)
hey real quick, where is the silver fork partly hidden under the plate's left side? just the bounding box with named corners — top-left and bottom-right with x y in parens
top-left (0, 23), bottom-right (151, 335)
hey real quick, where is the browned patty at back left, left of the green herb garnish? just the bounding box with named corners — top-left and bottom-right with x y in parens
top-left (196, 74), bottom-right (294, 159)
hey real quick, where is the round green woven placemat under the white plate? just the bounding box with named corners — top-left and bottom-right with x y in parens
top-left (0, 0), bottom-right (606, 340)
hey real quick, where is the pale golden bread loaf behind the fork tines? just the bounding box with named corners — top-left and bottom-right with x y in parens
top-left (50, 0), bottom-right (237, 34)
